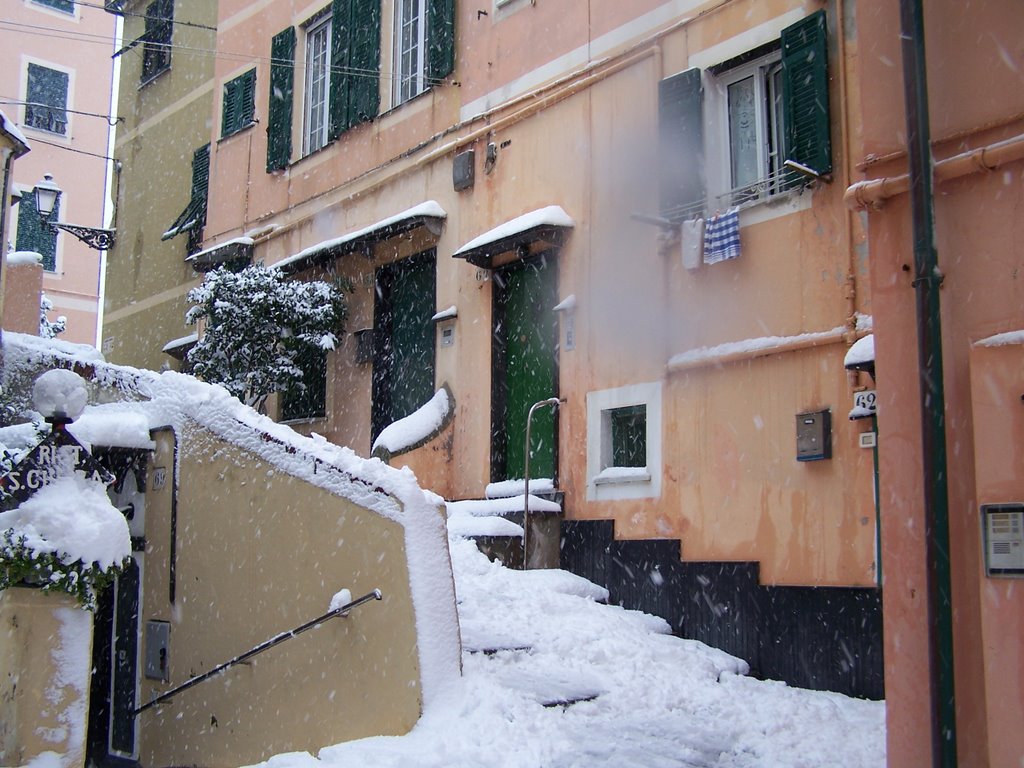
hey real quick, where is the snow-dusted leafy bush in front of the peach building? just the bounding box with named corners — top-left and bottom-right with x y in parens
top-left (185, 264), bottom-right (351, 411)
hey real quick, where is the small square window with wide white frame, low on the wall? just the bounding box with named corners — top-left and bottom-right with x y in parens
top-left (587, 382), bottom-right (662, 501)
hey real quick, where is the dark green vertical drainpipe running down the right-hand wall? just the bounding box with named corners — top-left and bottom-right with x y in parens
top-left (900, 0), bottom-right (956, 767)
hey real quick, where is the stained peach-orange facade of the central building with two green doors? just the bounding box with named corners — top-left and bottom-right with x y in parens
top-left (197, 0), bottom-right (877, 586)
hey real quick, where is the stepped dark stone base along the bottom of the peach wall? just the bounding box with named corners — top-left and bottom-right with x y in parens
top-left (561, 520), bottom-right (885, 699)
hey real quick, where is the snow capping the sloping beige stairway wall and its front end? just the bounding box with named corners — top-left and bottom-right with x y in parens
top-left (3, 333), bottom-right (461, 708)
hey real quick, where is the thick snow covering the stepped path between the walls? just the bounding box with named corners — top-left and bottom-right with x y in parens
top-left (251, 538), bottom-right (885, 768)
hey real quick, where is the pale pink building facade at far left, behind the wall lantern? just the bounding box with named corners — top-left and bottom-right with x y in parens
top-left (0, 0), bottom-right (115, 344)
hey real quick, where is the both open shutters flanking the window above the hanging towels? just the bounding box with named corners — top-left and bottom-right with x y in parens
top-left (658, 10), bottom-right (833, 219)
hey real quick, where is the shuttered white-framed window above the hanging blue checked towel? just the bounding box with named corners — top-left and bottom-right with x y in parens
top-left (658, 11), bottom-right (831, 221)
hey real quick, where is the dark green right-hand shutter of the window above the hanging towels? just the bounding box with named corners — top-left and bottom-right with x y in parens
top-left (781, 10), bottom-right (833, 174)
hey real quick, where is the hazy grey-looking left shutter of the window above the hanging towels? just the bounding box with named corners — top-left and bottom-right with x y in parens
top-left (657, 69), bottom-right (707, 220)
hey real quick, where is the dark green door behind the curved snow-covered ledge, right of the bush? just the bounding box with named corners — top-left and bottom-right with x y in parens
top-left (372, 251), bottom-right (436, 439)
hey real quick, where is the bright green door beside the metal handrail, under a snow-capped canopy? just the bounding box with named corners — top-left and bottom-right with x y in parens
top-left (490, 254), bottom-right (558, 481)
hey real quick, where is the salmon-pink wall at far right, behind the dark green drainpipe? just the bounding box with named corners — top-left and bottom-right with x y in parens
top-left (857, 0), bottom-right (1024, 766)
